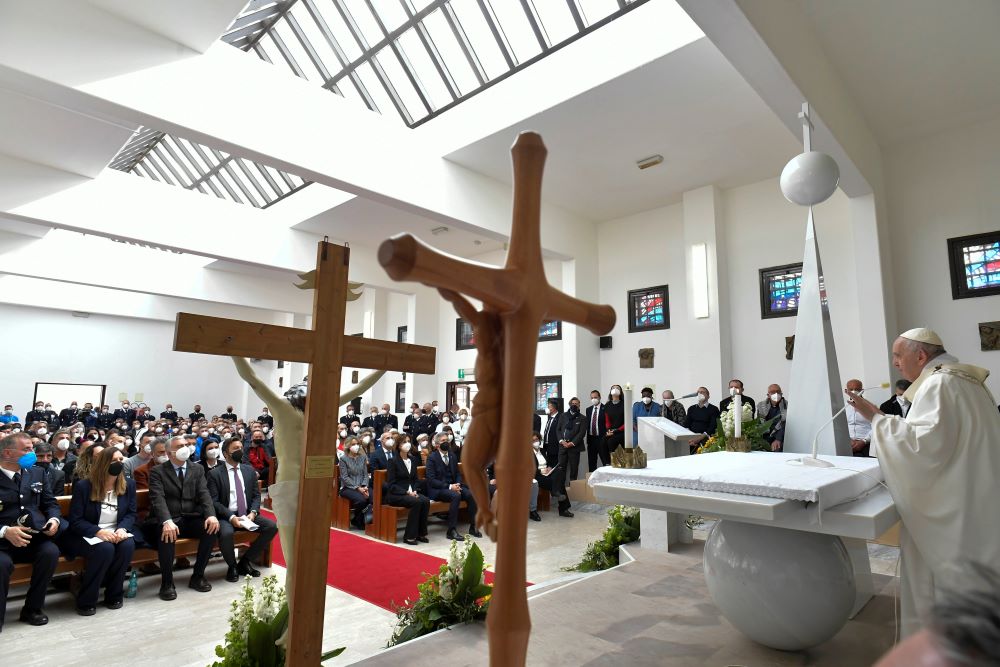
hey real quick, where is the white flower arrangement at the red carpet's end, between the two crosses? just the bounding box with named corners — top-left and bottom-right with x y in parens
top-left (388, 535), bottom-right (493, 646)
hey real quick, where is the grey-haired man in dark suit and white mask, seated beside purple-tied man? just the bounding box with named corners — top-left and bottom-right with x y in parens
top-left (145, 436), bottom-right (219, 600)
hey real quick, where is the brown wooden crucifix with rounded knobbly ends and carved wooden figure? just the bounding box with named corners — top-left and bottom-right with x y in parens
top-left (378, 132), bottom-right (615, 667)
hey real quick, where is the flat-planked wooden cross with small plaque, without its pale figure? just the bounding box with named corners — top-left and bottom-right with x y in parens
top-left (174, 241), bottom-right (435, 667)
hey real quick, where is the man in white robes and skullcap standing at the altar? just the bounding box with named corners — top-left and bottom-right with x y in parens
top-left (848, 329), bottom-right (1000, 635)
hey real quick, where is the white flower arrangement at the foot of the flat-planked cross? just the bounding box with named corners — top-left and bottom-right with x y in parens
top-left (211, 574), bottom-right (344, 667)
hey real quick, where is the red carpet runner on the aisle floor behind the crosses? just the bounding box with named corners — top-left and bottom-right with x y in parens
top-left (267, 513), bottom-right (493, 611)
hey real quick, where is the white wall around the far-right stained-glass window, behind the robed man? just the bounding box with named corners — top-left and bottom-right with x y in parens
top-left (883, 118), bottom-right (1000, 394)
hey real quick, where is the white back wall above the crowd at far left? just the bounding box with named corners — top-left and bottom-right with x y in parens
top-left (0, 304), bottom-right (275, 419)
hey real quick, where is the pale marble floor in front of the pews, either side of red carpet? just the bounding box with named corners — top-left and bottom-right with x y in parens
top-left (0, 504), bottom-right (607, 667)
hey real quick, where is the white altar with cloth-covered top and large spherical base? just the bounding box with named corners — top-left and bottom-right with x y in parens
top-left (589, 454), bottom-right (899, 650)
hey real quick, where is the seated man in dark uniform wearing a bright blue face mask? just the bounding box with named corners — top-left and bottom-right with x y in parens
top-left (0, 433), bottom-right (67, 630)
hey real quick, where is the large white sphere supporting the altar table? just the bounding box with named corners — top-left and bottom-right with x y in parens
top-left (704, 521), bottom-right (856, 651)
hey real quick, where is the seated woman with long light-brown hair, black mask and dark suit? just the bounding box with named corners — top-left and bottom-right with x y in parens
top-left (66, 447), bottom-right (141, 616)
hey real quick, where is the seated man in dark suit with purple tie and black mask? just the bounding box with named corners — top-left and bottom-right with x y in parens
top-left (208, 438), bottom-right (278, 581)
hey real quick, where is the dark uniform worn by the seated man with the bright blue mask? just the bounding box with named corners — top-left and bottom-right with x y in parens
top-left (0, 467), bottom-right (68, 627)
